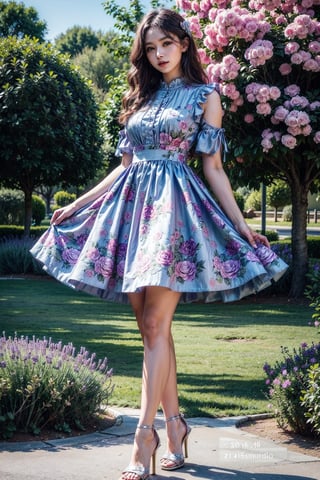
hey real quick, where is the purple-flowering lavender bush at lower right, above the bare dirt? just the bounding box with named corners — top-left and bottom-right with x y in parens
top-left (263, 343), bottom-right (320, 435)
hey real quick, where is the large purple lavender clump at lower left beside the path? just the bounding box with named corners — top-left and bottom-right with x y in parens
top-left (0, 333), bottom-right (113, 438)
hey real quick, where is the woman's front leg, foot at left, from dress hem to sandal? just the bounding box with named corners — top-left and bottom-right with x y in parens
top-left (122, 287), bottom-right (180, 480)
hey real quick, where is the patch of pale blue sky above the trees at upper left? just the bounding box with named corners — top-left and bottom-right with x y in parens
top-left (22, 0), bottom-right (129, 41)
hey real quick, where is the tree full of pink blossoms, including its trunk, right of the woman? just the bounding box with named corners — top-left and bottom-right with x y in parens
top-left (178, 0), bottom-right (320, 297)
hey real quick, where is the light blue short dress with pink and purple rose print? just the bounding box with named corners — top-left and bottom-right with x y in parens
top-left (31, 79), bottom-right (287, 303)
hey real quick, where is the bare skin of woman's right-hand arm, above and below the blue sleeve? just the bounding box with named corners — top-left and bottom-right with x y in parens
top-left (203, 92), bottom-right (270, 247)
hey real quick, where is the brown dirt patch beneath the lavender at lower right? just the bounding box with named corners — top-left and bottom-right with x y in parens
top-left (239, 418), bottom-right (320, 458)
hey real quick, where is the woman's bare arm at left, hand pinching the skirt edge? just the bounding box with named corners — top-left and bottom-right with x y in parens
top-left (51, 153), bottom-right (132, 225)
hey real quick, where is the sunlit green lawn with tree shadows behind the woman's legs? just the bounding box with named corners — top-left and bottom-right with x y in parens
top-left (0, 278), bottom-right (319, 416)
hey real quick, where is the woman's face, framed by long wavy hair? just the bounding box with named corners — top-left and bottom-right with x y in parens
top-left (145, 27), bottom-right (188, 82)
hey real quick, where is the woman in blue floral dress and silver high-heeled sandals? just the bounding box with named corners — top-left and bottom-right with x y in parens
top-left (32, 9), bottom-right (286, 480)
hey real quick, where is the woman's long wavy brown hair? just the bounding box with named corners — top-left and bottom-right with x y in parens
top-left (119, 8), bottom-right (208, 124)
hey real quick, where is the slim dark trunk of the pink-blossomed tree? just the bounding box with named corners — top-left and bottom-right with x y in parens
top-left (289, 182), bottom-right (308, 298)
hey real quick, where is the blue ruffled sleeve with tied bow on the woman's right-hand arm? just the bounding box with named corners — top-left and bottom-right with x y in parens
top-left (195, 120), bottom-right (228, 161)
